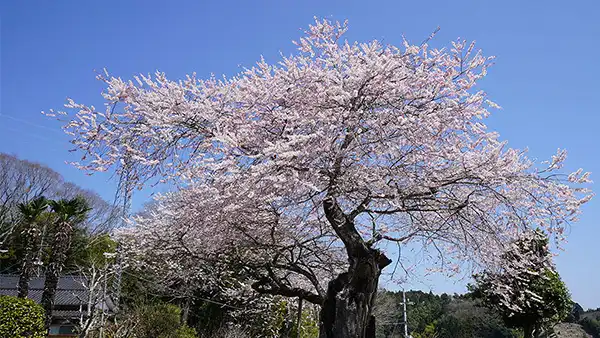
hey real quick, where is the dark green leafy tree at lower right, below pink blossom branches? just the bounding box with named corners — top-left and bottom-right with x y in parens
top-left (470, 230), bottom-right (573, 338)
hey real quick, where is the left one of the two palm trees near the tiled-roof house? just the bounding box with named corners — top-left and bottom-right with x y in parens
top-left (18, 196), bottom-right (48, 298)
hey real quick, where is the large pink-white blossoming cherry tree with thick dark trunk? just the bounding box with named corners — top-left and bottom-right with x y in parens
top-left (49, 20), bottom-right (592, 337)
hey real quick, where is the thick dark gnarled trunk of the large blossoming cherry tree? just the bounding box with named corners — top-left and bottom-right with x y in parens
top-left (319, 197), bottom-right (391, 338)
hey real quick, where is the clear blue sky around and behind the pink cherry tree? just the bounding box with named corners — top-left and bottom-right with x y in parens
top-left (0, 0), bottom-right (600, 308)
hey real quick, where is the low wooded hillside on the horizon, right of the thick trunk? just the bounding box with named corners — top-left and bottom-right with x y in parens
top-left (375, 290), bottom-right (600, 338)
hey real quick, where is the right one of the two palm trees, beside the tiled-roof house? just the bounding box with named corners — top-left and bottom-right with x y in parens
top-left (42, 196), bottom-right (90, 328)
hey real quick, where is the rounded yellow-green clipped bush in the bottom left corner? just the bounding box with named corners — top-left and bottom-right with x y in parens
top-left (0, 296), bottom-right (46, 338)
